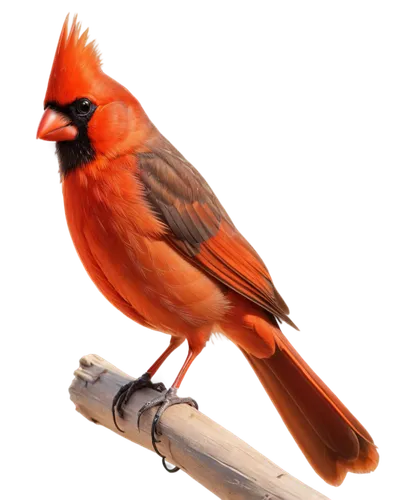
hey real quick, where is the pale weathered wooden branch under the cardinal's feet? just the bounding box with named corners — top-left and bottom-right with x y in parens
top-left (68, 353), bottom-right (327, 500)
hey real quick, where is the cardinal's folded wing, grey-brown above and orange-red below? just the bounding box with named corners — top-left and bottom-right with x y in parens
top-left (137, 138), bottom-right (298, 329)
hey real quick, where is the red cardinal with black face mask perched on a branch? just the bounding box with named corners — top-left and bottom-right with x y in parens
top-left (36, 14), bottom-right (380, 487)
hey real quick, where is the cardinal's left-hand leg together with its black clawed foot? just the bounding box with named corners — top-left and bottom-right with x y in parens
top-left (112, 338), bottom-right (183, 432)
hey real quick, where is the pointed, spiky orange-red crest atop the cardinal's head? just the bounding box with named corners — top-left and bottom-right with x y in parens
top-left (42, 12), bottom-right (104, 105)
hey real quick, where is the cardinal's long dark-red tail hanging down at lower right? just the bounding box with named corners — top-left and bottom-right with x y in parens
top-left (238, 331), bottom-right (381, 487)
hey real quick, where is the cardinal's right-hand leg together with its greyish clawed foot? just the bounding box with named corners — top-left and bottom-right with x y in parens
top-left (138, 349), bottom-right (202, 473)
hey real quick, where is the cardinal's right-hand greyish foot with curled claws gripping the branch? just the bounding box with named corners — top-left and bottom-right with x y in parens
top-left (137, 387), bottom-right (200, 474)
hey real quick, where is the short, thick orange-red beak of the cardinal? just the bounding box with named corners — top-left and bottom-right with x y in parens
top-left (36, 108), bottom-right (78, 142)
